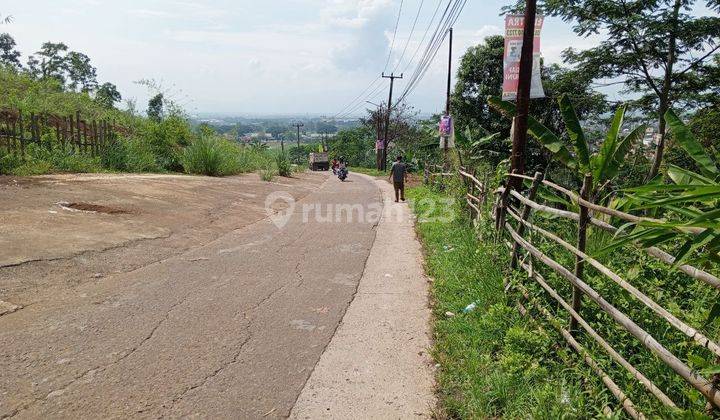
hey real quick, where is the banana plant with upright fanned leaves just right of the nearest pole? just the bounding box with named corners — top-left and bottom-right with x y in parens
top-left (489, 95), bottom-right (646, 195)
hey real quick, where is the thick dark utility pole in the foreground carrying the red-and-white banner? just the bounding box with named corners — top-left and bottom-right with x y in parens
top-left (510, 0), bottom-right (537, 189)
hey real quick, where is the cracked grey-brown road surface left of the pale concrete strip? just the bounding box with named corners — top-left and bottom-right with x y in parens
top-left (0, 172), bottom-right (381, 418)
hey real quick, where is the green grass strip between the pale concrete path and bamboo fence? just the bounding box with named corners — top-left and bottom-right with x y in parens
top-left (408, 186), bottom-right (622, 419)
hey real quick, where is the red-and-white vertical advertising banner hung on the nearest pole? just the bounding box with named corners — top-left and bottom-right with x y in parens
top-left (503, 15), bottom-right (545, 101)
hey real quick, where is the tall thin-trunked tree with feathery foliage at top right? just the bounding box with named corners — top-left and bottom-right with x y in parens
top-left (545, 0), bottom-right (720, 178)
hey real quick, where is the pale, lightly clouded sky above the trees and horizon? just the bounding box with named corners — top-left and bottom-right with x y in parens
top-left (0, 0), bottom-right (598, 116)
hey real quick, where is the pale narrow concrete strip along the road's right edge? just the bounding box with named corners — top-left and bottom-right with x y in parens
top-left (290, 174), bottom-right (435, 419)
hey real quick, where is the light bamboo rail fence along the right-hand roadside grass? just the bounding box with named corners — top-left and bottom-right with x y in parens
top-left (426, 169), bottom-right (720, 419)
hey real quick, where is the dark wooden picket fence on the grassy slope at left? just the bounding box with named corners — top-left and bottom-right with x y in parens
top-left (0, 110), bottom-right (118, 157)
